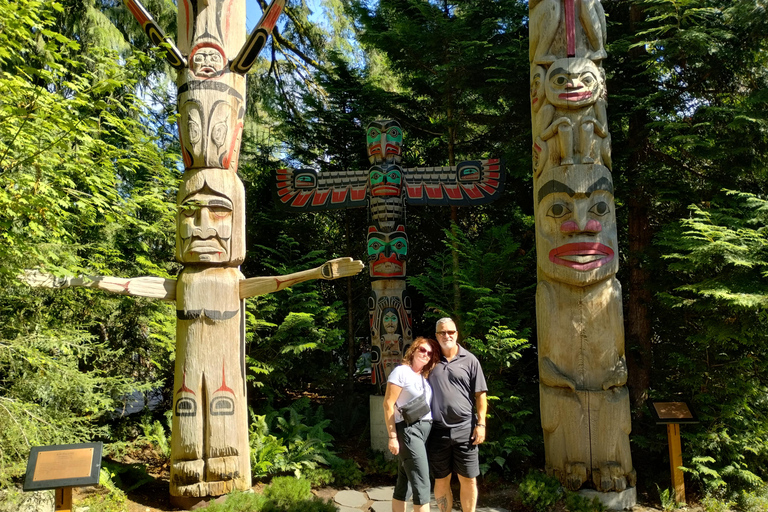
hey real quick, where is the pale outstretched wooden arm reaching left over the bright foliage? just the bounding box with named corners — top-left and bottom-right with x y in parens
top-left (19, 270), bottom-right (176, 300)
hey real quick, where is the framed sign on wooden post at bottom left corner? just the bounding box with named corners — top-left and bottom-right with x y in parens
top-left (24, 443), bottom-right (102, 512)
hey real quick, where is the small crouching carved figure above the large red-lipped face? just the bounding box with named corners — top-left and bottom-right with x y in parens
top-left (534, 59), bottom-right (611, 169)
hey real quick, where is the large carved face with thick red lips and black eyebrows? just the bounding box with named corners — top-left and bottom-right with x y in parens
top-left (536, 165), bottom-right (619, 286)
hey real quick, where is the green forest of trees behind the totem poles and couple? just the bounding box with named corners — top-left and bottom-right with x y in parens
top-left (0, 0), bottom-right (768, 506)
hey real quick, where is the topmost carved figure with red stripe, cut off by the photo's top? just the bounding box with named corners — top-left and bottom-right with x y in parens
top-left (528, 0), bottom-right (607, 65)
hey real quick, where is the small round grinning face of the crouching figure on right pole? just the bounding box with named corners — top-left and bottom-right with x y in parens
top-left (544, 58), bottom-right (603, 109)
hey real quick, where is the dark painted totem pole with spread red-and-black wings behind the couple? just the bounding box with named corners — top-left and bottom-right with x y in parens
top-left (275, 120), bottom-right (504, 386)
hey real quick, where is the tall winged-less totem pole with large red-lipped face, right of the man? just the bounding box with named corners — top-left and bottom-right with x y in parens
top-left (529, 0), bottom-right (636, 498)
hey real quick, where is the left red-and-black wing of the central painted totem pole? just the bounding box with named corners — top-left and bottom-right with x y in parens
top-left (274, 169), bottom-right (368, 212)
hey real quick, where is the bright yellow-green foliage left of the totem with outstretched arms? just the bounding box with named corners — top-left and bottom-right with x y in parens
top-left (0, 0), bottom-right (177, 478)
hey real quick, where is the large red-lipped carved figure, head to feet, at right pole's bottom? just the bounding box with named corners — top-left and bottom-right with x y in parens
top-left (534, 165), bottom-right (636, 491)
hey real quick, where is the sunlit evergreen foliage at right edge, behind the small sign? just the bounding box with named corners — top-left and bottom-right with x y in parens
top-left (655, 190), bottom-right (768, 488)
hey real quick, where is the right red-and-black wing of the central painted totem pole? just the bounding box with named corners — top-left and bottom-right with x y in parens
top-left (403, 158), bottom-right (504, 206)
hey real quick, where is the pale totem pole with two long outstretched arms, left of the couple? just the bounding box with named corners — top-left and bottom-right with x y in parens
top-left (24, 0), bottom-right (363, 506)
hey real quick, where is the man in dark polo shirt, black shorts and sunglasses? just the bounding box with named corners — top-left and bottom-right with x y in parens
top-left (427, 318), bottom-right (488, 512)
